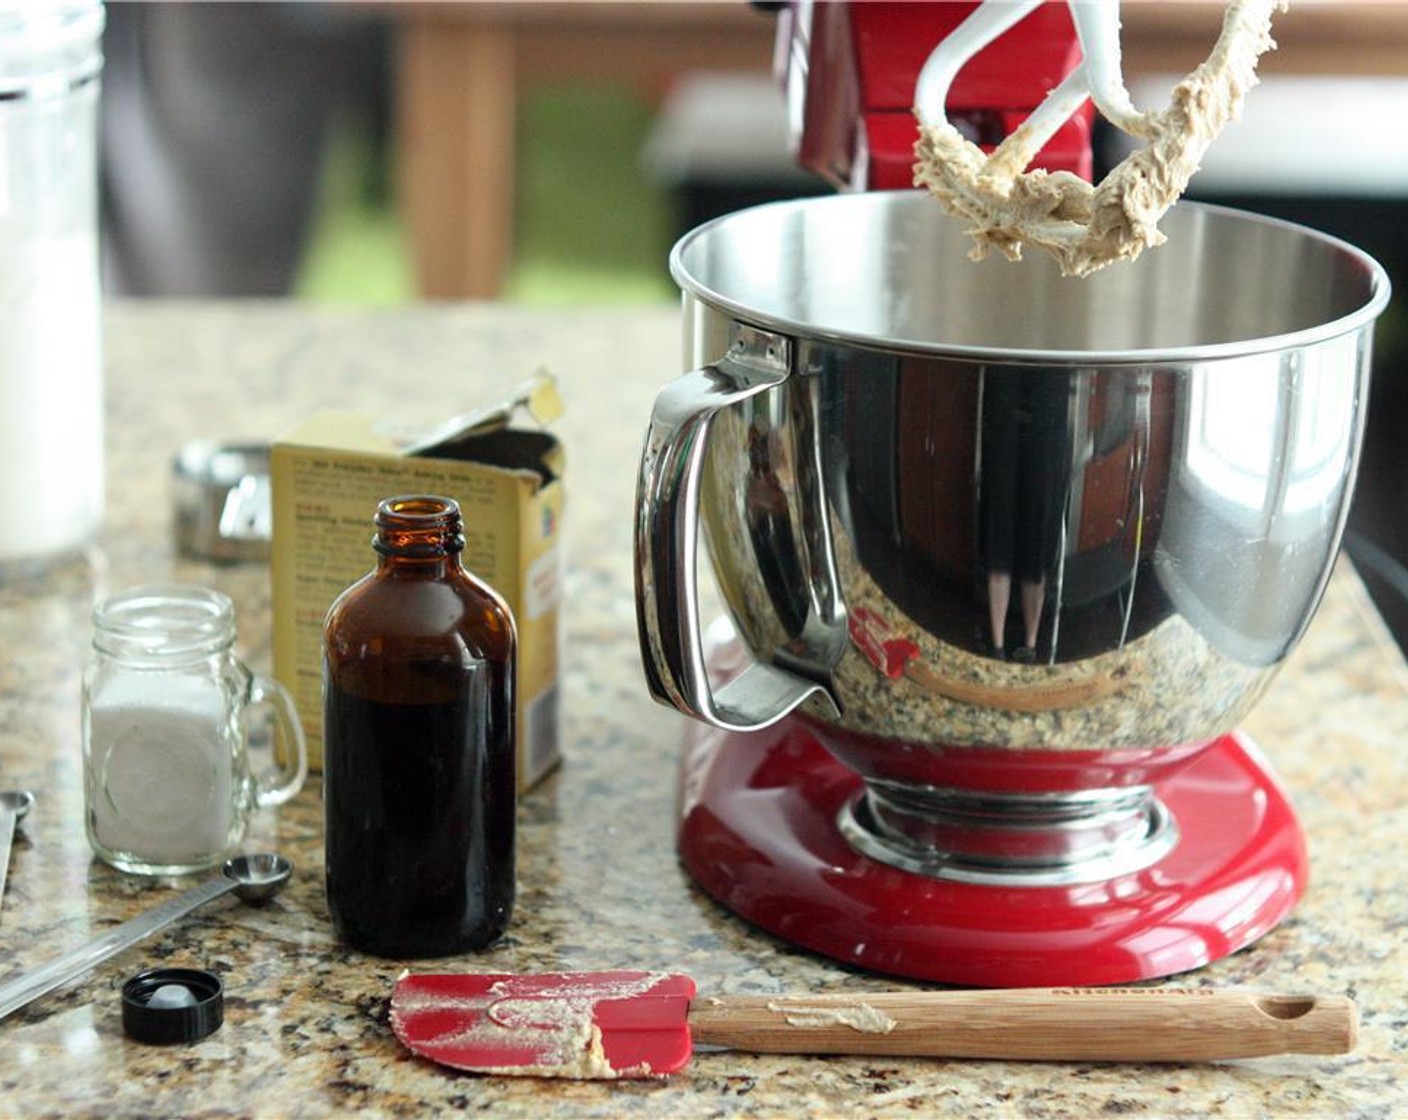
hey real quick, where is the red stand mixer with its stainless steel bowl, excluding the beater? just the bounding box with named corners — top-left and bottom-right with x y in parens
top-left (635, 3), bottom-right (1388, 986)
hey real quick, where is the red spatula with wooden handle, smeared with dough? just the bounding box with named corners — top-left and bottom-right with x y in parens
top-left (391, 971), bottom-right (1357, 1078)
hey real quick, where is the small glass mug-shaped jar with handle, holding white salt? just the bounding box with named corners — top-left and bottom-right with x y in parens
top-left (83, 586), bottom-right (307, 875)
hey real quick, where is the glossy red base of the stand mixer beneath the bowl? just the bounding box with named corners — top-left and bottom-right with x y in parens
top-left (679, 721), bottom-right (1307, 988)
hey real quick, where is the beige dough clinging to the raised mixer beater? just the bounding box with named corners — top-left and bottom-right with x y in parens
top-left (914, 0), bottom-right (1286, 276)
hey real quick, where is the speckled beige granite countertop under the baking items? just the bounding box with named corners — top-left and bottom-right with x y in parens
top-left (0, 303), bottom-right (1408, 1117)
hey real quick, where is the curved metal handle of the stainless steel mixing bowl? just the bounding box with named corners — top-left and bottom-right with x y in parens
top-left (635, 327), bottom-right (829, 731)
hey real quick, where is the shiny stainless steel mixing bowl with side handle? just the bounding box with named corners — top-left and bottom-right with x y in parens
top-left (636, 192), bottom-right (1388, 878)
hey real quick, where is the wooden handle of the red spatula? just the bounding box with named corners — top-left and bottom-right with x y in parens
top-left (690, 988), bottom-right (1359, 1062)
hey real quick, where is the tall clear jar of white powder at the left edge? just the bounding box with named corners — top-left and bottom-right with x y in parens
top-left (0, 0), bottom-right (104, 580)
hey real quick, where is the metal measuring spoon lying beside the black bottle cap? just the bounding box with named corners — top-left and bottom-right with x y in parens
top-left (0, 852), bottom-right (293, 1019)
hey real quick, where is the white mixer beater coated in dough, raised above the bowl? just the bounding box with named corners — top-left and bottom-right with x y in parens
top-left (914, 0), bottom-right (1286, 276)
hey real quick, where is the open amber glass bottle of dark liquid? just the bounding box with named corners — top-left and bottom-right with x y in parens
top-left (322, 496), bottom-right (517, 957)
